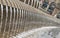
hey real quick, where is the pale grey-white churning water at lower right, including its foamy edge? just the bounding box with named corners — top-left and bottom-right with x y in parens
top-left (12, 27), bottom-right (60, 38)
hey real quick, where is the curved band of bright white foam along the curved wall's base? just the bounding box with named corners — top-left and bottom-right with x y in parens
top-left (11, 26), bottom-right (59, 38)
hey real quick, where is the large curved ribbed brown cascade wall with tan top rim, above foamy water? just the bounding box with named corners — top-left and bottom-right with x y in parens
top-left (0, 0), bottom-right (60, 38)
